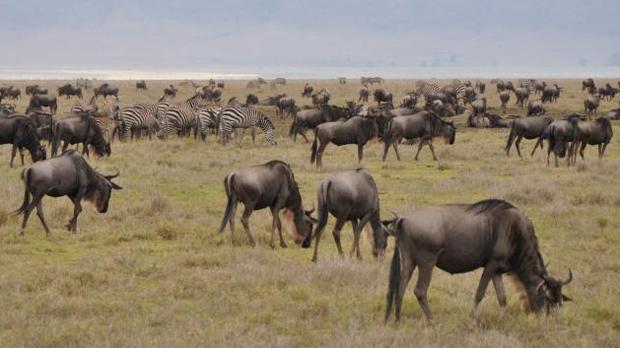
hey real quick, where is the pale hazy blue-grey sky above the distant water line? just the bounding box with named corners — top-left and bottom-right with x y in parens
top-left (0, 0), bottom-right (620, 69)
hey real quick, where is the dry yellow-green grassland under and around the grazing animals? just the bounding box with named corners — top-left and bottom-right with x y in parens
top-left (0, 81), bottom-right (620, 347)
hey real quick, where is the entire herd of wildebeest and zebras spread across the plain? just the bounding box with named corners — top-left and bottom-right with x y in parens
top-left (0, 77), bottom-right (619, 321)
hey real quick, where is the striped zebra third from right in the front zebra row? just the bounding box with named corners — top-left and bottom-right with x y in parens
top-left (157, 94), bottom-right (206, 139)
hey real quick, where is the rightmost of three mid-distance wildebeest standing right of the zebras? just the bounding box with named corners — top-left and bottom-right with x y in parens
top-left (383, 111), bottom-right (456, 161)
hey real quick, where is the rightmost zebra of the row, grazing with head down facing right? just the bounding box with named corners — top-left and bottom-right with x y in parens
top-left (219, 106), bottom-right (276, 145)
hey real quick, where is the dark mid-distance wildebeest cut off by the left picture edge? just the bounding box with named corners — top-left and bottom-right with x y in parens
top-left (0, 115), bottom-right (46, 168)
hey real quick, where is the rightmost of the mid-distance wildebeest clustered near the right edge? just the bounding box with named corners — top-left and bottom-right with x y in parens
top-left (571, 117), bottom-right (614, 163)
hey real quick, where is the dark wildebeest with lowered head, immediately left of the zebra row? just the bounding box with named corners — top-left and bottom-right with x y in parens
top-left (52, 114), bottom-right (112, 157)
